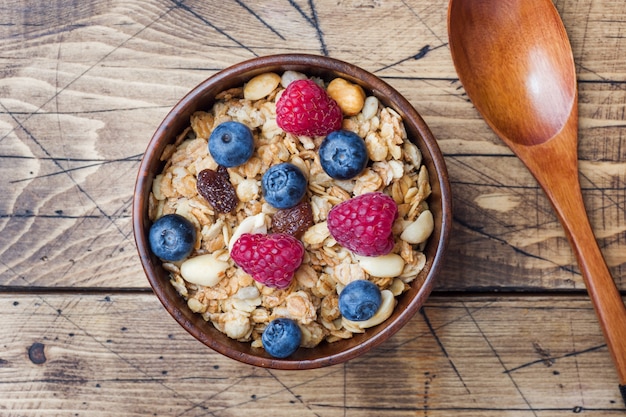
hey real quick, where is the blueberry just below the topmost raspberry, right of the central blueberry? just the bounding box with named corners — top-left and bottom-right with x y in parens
top-left (319, 130), bottom-right (369, 180)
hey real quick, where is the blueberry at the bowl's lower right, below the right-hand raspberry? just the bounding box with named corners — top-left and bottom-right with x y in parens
top-left (339, 279), bottom-right (382, 321)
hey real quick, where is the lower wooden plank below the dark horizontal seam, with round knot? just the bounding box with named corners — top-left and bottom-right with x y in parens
top-left (0, 293), bottom-right (624, 417)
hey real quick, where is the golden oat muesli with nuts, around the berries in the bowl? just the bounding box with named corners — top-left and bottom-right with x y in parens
top-left (149, 71), bottom-right (433, 348)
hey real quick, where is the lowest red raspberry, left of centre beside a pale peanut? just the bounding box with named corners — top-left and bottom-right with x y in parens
top-left (230, 233), bottom-right (304, 289)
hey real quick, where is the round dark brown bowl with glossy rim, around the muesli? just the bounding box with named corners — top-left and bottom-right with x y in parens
top-left (133, 54), bottom-right (452, 369)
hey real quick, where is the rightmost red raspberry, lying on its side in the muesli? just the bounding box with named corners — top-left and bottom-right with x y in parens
top-left (328, 193), bottom-right (398, 256)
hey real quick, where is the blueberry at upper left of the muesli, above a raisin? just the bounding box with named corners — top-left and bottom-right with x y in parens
top-left (209, 121), bottom-right (254, 168)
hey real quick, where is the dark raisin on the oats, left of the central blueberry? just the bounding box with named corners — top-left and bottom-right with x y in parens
top-left (196, 165), bottom-right (239, 213)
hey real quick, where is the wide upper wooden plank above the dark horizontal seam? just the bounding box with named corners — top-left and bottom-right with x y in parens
top-left (0, 0), bottom-right (626, 290)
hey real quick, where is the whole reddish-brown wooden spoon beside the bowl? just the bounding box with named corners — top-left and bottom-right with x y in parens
top-left (448, 0), bottom-right (626, 402)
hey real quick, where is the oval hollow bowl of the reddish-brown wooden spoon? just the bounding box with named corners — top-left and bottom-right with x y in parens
top-left (449, 1), bottom-right (577, 145)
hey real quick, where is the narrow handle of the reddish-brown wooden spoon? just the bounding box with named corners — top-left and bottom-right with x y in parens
top-left (515, 118), bottom-right (626, 396)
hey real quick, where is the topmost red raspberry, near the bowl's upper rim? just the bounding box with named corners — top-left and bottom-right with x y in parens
top-left (276, 80), bottom-right (343, 136)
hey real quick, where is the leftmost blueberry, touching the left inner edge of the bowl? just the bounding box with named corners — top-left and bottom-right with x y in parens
top-left (148, 214), bottom-right (196, 261)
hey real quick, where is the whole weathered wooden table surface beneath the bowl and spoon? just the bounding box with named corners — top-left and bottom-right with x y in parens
top-left (0, 0), bottom-right (626, 417)
